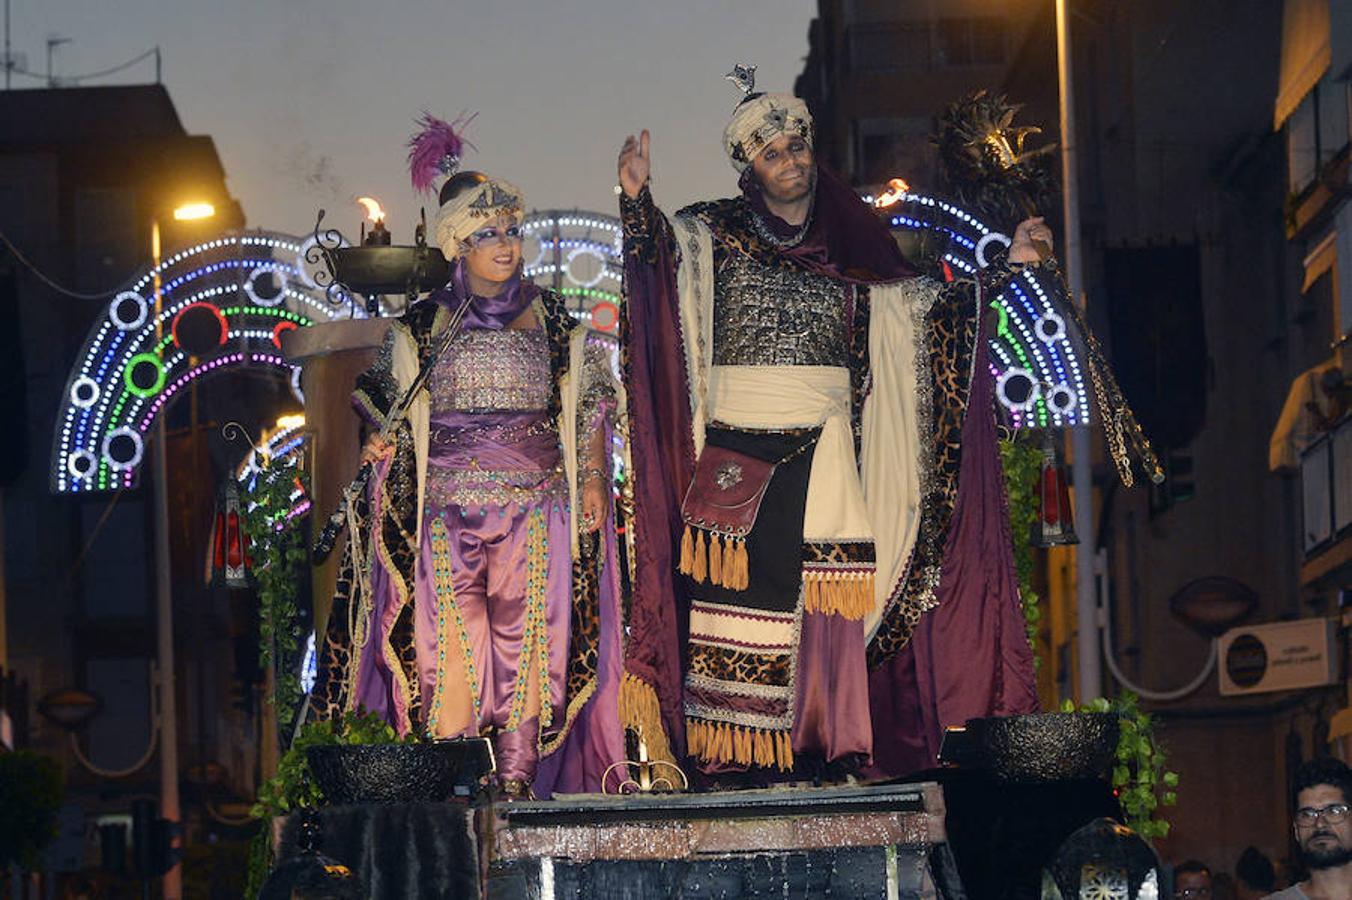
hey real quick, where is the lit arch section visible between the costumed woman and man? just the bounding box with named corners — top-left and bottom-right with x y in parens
top-left (522, 209), bottom-right (625, 332)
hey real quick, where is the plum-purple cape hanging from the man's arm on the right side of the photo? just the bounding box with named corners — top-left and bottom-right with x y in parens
top-left (869, 297), bottom-right (1038, 777)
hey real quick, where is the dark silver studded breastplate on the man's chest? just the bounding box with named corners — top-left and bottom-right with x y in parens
top-left (714, 253), bottom-right (849, 366)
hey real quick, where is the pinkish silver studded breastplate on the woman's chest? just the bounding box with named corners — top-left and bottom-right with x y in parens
top-left (427, 328), bottom-right (550, 414)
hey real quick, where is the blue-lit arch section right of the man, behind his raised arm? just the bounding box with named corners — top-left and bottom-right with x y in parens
top-left (888, 192), bottom-right (1090, 428)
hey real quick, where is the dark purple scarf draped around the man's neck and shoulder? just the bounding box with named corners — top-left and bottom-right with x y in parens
top-left (738, 164), bottom-right (917, 284)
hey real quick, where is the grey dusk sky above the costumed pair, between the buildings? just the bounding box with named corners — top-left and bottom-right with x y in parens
top-left (11, 0), bottom-right (817, 241)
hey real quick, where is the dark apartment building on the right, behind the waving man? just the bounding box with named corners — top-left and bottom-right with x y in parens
top-left (798, 0), bottom-right (1352, 872)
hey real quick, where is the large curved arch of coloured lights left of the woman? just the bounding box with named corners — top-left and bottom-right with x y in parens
top-left (51, 231), bottom-right (365, 493)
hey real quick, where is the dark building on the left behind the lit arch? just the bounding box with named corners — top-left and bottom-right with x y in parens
top-left (0, 85), bottom-right (274, 891)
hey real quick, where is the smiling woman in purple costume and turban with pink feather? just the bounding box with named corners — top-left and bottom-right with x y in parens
top-left (315, 118), bottom-right (623, 796)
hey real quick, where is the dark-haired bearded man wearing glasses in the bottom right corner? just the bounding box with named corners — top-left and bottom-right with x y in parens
top-left (1268, 759), bottom-right (1352, 900)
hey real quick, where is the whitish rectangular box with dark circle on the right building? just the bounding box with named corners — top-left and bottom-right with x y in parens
top-left (1217, 618), bottom-right (1340, 697)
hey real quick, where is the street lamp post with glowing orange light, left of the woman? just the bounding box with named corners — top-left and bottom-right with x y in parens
top-left (150, 203), bottom-right (215, 900)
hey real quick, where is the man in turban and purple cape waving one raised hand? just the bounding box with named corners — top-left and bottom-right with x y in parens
top-left (619, 66), bottom-right (1051, 774)
